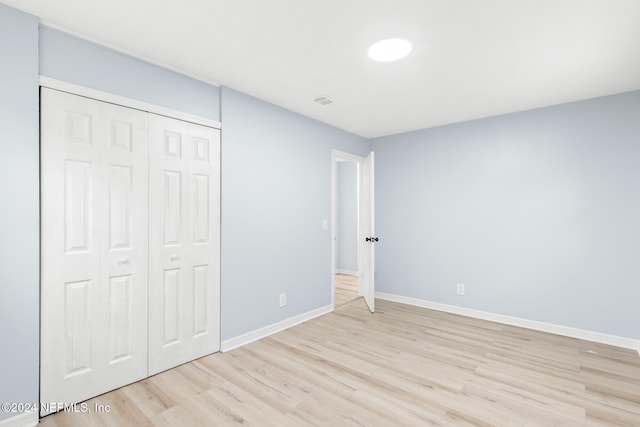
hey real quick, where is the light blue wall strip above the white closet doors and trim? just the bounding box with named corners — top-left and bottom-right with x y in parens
top-left (40, 27), bottom-right (220, 121)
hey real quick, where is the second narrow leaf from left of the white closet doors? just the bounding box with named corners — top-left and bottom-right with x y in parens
top-left (100, 103), bottom-right (149, 388)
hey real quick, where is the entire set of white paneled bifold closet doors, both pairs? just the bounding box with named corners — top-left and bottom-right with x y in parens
top-left (40, 88), bottom-right (220, 415)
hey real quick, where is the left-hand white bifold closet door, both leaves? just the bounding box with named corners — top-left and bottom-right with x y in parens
top-left (40, 88), bottom-right (148, 415)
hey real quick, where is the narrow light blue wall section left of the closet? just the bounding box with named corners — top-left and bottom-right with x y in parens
top-left (0, 3), bottom-right (40, 421)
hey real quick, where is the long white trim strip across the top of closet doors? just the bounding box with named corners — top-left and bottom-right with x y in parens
top-left (40, 76), bottom-right (222, 129)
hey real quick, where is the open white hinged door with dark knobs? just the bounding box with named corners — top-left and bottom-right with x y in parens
top-left (359, 152), bottom-right (378, 313)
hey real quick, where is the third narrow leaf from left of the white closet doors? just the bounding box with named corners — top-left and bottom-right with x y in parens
top-left (149, 115), bottom-right (191, 374)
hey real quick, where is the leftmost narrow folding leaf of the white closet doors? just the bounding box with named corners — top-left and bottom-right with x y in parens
top-left (41, 90), bottom-right (102, 415)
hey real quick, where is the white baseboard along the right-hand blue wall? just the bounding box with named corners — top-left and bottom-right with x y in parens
top-left (376, 292), bottom-right (640, 355)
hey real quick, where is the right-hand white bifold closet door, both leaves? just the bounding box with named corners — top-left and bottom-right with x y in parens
top-left (149, 115), bottom-right (220, 375)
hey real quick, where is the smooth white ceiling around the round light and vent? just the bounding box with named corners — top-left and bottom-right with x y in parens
top-left (5, 0), bottom-right (640, 137)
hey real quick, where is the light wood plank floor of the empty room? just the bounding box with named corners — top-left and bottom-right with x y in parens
top-left (42, 290), bottom-right (640, 427)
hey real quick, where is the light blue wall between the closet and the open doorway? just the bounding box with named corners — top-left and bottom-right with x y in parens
top-left (221, 87), bottom-right (369, 340)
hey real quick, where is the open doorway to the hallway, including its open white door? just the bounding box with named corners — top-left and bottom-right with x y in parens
top-left (331, 150), bottom-right (374, 312)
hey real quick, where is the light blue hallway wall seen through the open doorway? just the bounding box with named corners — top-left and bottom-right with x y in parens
top-left (336, 162), bottom-right (358, 273)
